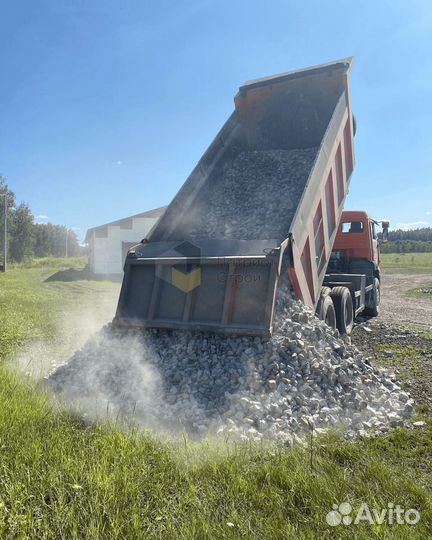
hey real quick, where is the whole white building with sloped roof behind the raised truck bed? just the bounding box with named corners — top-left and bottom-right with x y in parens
top-left (85, 207), bottom-right (165, 276)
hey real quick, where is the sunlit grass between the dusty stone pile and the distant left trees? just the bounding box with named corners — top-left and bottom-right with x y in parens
top-left (0, 258), bottom-right (119, 372)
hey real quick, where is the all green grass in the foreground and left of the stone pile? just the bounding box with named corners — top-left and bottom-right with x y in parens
top-left (0, 261), bottom-right (432, 540)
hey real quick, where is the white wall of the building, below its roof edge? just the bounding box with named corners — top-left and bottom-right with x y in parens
top-left (90, 217), bottom-right (158, 274)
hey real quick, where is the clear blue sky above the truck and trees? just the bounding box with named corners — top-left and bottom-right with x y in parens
top-left (0, 0), bottom-right (432, 237)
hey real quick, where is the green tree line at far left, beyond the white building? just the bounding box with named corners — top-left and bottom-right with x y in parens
top-left (0, 176), bottom-right (83, 262)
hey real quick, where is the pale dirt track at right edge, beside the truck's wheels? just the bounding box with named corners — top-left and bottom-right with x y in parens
top-left (379, 274), bottom-right (432, 327)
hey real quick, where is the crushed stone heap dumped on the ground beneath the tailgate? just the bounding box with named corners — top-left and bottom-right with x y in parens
top-left (49, 290), bottom-right (413, 444)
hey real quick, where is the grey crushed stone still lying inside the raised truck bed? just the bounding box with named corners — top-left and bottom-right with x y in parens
top-left (186, 147), bottom-right (318, 240)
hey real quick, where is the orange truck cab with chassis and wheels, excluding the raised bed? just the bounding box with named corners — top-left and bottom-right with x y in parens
top-left (317, 211), bottom-right (389, 334)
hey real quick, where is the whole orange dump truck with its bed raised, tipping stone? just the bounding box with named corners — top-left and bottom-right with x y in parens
top-left (113, 58), bottom-right (388, 337)
